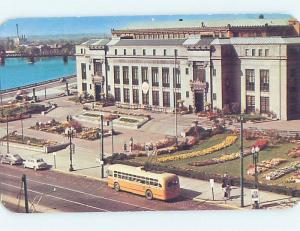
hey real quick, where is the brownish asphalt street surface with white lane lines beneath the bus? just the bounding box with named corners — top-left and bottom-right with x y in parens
top-left (0, 164), bottom-right (224, 212)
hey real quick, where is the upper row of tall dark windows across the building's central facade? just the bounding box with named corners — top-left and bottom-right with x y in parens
top-left (114, 66), bottom-right (180, 88)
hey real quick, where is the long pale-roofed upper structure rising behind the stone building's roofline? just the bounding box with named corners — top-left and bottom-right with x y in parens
top-left (111, 19), bottom-right (300, 39)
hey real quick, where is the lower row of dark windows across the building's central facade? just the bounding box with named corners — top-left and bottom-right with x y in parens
top-left (114, 88), bottom-right (182, 107)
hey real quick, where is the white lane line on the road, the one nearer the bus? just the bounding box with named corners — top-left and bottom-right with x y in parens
top-left (0, 173), bottom-right (157, 211)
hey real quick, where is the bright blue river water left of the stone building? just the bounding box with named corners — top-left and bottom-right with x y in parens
top-left (0, 57), bottom-right (76, 90)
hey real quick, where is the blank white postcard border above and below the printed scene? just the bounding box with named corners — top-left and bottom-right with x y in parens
top-left (0, 0), bottom-right (300, 231)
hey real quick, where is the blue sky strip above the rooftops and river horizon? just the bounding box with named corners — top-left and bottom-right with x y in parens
top-left (0, 13), bottom-right (291, 37)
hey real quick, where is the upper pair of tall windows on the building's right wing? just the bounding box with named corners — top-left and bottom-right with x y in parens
top-left (245, 69), bottom-right (270, 92)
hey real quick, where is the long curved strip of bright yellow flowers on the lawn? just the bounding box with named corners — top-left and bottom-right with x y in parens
top-left (156, 136), bottom-right (238, 163)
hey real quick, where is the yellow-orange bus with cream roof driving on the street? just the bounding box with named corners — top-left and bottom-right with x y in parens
top-left (107, 164), bottom-right (180, 200)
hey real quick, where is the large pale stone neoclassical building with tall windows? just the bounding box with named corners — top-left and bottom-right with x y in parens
top-left (76, 18), bottom-right (300, 120)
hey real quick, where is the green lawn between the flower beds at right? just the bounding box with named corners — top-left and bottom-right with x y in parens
top-left (133, 134), bottom-right (300, 189)
